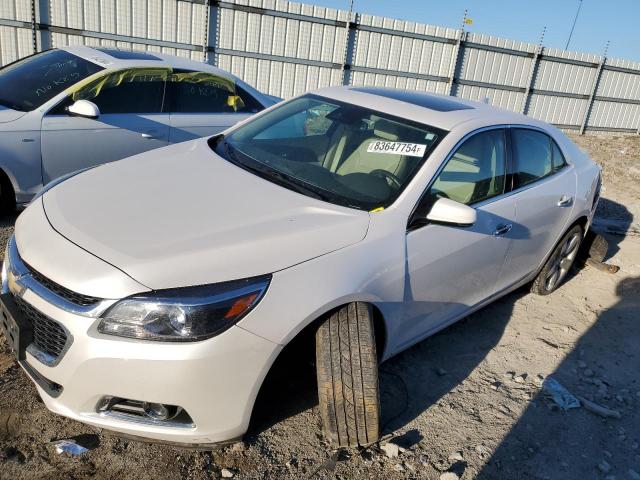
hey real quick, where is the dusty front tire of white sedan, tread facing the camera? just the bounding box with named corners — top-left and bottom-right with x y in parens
top-left (316, 302), bottom-right (380, 447)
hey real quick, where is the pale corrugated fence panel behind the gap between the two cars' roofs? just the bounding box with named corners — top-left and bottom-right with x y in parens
top-left (217, 0), bottom-right (349, 98)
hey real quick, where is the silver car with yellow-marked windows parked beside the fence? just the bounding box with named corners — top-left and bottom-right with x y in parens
top-left (0, 46), bottom-right (277, 209)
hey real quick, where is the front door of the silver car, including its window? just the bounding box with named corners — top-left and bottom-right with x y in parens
top-left (42, 69), bottom-right (170, 184)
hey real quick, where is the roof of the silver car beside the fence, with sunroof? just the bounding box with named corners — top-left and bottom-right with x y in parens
top-left (60, 45), bottom-right (238, 80)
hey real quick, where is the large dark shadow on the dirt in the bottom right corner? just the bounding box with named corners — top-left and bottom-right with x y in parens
top-left (477, 273), bottom-right (640, 480)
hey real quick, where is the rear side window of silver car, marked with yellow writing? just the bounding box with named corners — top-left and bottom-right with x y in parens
top-left (165, 72), bottom-right (264, 113)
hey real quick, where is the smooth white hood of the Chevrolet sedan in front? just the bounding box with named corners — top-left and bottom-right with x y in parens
top-left (42, 139), bottom-right (369, 289)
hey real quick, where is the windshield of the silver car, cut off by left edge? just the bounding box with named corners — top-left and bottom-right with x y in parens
top-left (0, 50), bottom-right (103, 112)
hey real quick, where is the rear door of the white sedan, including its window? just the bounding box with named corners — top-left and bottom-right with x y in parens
top-left (500, 128), bottom-right (576, 288)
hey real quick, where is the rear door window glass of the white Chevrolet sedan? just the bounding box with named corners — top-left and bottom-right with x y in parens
top-left (511, 128), bottom-right (564, 188)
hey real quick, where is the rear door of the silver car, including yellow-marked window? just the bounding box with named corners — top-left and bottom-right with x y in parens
top-left (165, 70), bottom-right (264, 143)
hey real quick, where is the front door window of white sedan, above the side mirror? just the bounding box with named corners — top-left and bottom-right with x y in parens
top-left (426, 129), bottom-right (506, 205)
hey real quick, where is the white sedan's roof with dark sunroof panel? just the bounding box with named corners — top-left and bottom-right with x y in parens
top-left (312, 86), bottom-right (553, 130)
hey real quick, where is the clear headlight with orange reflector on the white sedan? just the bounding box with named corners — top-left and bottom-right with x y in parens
top-left (98, 275), bottom-right (271, 342)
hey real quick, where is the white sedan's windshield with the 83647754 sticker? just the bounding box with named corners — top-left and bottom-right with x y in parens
top-left (209, 95), bottom-right (445, 210)
